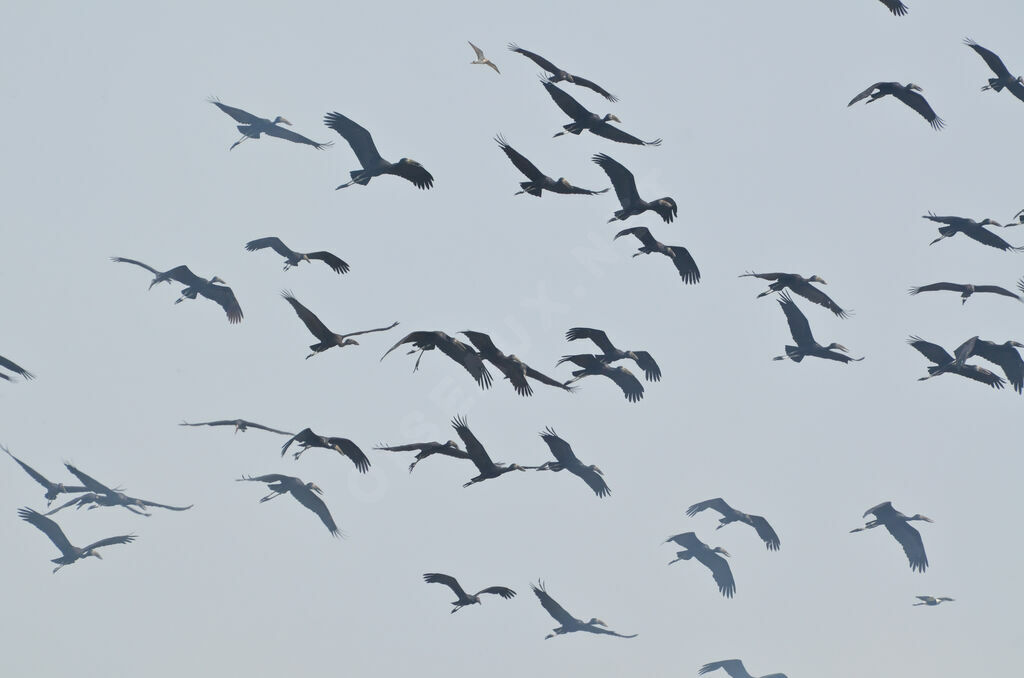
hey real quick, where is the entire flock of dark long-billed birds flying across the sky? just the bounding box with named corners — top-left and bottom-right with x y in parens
top-left (0, 5), bottom-right (1024, 678)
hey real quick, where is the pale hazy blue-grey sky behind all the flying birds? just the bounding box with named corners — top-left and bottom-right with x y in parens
top-left (0, 0), bottom-right (1024, 678)
